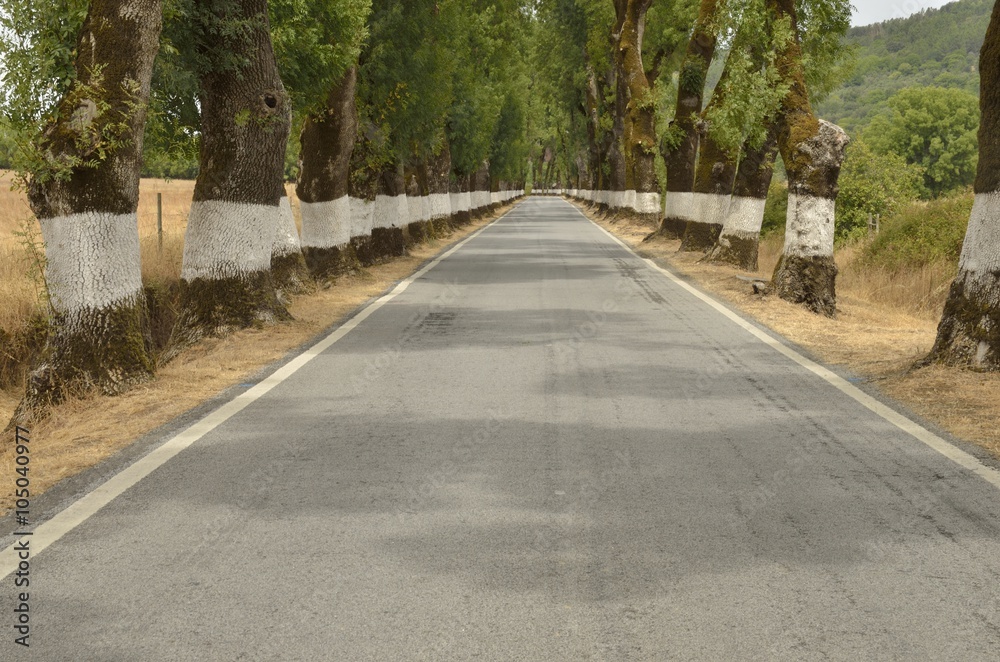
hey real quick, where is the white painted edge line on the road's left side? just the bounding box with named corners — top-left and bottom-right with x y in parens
top-left (0, 207), bottom-right (517, 580)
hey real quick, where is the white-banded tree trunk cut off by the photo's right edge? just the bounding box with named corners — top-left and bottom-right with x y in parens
top-left (928, 4), bottom-right (1000, 371)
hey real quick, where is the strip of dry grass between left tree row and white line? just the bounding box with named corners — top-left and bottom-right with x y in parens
top-left (0, 211), bottom-right (500, 511)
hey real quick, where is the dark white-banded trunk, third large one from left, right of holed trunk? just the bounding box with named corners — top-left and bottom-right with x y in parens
top-left (296, 67), bottom-right (359, 279)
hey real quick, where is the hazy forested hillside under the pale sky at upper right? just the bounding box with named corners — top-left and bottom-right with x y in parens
top-left (819, 0), bottom-right (993, 133)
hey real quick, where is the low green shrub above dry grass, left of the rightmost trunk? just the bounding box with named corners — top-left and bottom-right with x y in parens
top-left (861, 191), bottom-right (974, 270)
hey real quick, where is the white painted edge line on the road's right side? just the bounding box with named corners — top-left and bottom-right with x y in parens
top-left (572, 205), bottom-right (1000, 489)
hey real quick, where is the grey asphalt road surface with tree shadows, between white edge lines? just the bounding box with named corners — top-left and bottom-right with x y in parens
top-left (0, 198), bottom-right (1000, 661)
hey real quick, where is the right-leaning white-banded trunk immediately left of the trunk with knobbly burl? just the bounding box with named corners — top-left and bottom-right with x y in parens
top-left (709, 125), bottom-right (778, 271)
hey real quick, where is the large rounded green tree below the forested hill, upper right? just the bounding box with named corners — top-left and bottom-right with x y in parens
top-left (864, 87), bottom-right (979, 197)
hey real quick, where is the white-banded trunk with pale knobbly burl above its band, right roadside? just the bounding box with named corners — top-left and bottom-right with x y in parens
top-left (771, 0), bottom-right (850, 317)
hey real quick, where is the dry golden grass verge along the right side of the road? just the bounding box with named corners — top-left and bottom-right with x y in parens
top-left (585, 210), bottom-right (1000, 457)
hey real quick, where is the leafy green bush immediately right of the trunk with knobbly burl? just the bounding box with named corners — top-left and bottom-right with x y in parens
top-left (836, 140), bottom-right (923, 241)
